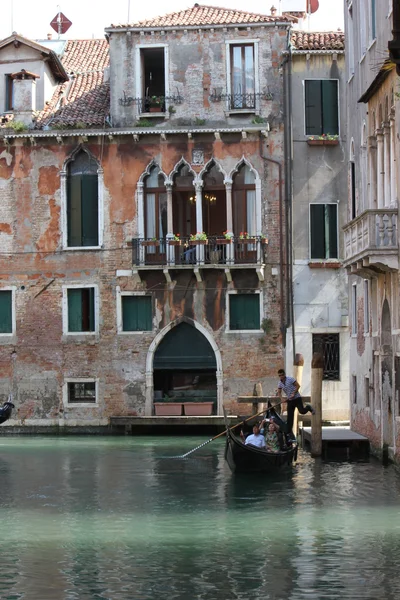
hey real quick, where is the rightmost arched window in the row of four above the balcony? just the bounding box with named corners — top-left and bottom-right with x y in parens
top-left (232, 164), bottom-right (257, 236)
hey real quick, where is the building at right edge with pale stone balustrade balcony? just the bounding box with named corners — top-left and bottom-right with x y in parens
top-left (344, 0), bottom-right (400, 461)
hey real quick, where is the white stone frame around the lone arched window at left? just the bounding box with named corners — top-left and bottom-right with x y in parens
top-left (60, 144), bottom-right (104, 252)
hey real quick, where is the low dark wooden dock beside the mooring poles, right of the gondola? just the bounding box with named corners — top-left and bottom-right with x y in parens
top-left (300, 427), bottom-right (369, 459)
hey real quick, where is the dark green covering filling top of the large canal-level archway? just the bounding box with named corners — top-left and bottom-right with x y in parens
top-left (153, 323), bottom-right (217, 370)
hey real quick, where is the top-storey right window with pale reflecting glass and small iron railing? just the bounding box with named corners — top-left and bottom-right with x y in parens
top-left (230, 44), bottom-right (256, 110)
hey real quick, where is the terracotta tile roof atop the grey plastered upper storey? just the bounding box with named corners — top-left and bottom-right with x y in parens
top-left (107, 4), bottom-right (296, 29)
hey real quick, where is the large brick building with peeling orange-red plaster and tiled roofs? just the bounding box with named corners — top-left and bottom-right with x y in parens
top-left (0, 5), bottom-right (295, 427)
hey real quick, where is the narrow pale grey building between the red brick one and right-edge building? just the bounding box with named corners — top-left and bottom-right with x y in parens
top-left (286, 31), bottom-right (349, 421)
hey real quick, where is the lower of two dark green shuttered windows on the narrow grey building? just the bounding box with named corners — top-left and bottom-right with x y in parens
top-left (310, 204), bottom-right (338, 259)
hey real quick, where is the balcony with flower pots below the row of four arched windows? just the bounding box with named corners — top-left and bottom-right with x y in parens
top-left (132, 236), bottom-right (268, 281)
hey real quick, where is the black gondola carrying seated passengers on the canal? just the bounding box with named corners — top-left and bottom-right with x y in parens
top-left (225, 409), bottom-right (298, 473)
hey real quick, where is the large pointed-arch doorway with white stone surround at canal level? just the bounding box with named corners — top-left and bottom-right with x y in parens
top-left (145, 317), bottom-right (222, 416)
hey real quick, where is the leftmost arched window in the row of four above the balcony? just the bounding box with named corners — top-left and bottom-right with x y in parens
top-left (144, 166), bottom-right (167, 240)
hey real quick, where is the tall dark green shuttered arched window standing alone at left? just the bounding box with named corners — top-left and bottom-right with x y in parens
top-left (67, 150), bottom-right (99, 247)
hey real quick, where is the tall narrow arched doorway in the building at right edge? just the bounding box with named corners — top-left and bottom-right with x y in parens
top-left (381, 300), bottom-right (394, 447)
